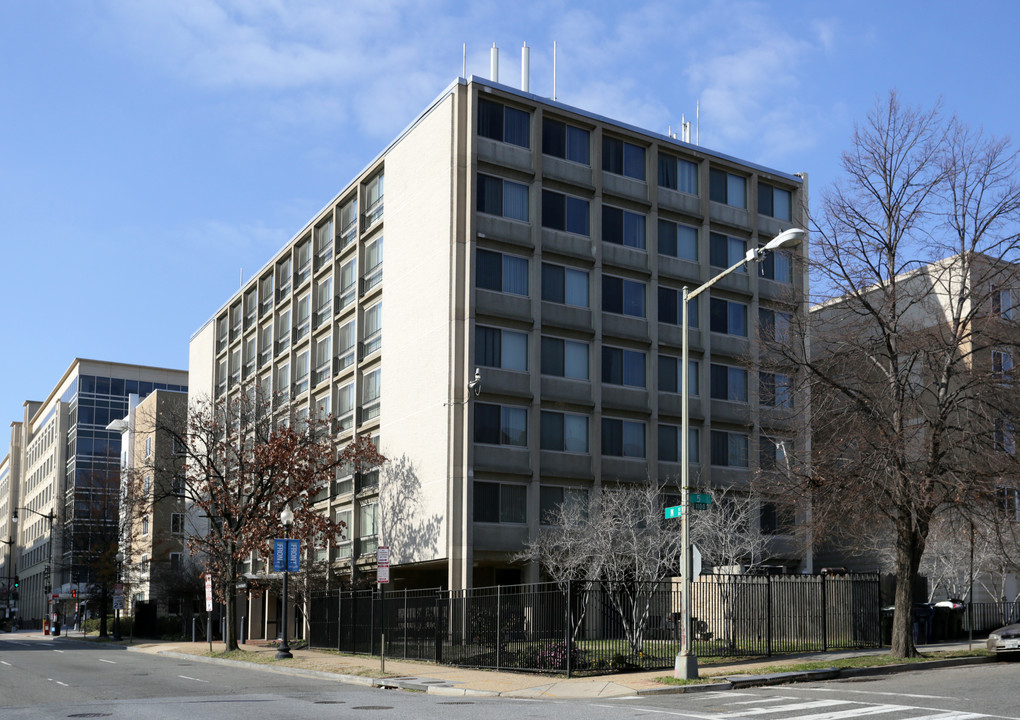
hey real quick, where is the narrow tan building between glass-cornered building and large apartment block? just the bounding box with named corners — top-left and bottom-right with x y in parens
top-left (109, 390), bottom-right (208, 616)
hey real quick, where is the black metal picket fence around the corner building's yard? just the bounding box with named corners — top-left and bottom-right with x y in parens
top-left (309, 575), bottom-right (881, 674)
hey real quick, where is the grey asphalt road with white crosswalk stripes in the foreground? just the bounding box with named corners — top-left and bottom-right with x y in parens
top-left (0, 635), bottom-right (1020, 720)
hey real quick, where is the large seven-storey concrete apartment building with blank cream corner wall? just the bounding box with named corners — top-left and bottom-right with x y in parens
top-left (189, 72), bottom-right (811, 588)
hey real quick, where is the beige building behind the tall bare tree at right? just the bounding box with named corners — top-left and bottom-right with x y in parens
top-left (810, 253), bottom-right (1020, 602)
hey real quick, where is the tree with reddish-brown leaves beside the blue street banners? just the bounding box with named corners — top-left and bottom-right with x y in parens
top-left (139, 394), bottom-right (385, 650)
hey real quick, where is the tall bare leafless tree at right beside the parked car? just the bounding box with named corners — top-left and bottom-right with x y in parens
top-left (771, 93), bottom-right (1020, 657)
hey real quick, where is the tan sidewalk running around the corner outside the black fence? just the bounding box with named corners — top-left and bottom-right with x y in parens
top-left (25, 630), bottom-right (995, 700)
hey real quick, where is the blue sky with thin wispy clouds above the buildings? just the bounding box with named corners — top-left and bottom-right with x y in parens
top-left (0, 0), bottom-right (1020, 453)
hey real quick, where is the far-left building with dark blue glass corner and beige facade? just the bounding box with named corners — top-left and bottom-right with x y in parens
top-left (0, 359), bottom-right (188, 627)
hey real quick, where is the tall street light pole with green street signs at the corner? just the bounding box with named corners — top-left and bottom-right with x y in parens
top-left (673, 227), bottom-right (807, 680)
